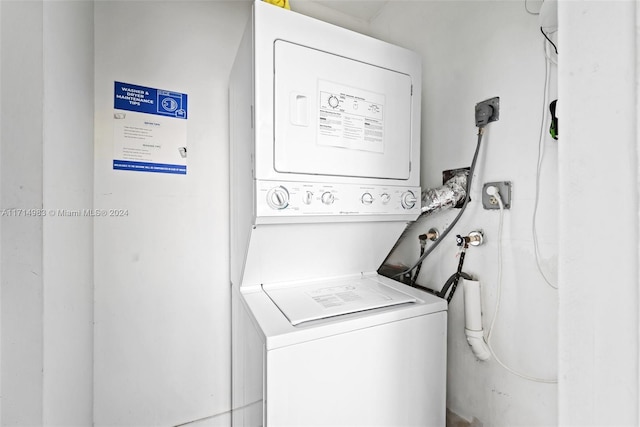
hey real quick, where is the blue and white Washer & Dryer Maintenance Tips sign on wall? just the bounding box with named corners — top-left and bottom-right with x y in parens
top-left (113, 82), bottom-right (188, 175)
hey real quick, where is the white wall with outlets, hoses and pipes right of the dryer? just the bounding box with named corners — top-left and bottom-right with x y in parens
top-left (371, 1), bottom-right (557, 427)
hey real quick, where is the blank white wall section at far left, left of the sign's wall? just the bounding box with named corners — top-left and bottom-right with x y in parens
top-left (0, 1), bottom-right (93, 425)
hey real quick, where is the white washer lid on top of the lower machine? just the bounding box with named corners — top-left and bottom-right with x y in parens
top-left (264, 277), bottom-right (418, 325)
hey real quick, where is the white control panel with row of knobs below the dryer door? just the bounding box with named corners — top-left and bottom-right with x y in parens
top-left (256, 181), bottom-right (421, 219)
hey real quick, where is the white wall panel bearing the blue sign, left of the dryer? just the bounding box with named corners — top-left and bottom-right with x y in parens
top-left (94, 1), bottom-right (250, 426)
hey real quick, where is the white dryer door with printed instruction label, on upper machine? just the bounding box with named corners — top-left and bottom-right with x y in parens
top-left (274, 40), bottom-right (412, 180)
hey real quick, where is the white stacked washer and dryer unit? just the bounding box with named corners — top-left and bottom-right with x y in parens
top-left (229, 1), bottom-right (447, 427)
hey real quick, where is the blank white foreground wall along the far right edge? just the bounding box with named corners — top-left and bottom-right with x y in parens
top-left (559, 1), bottom-right (640, 426)
